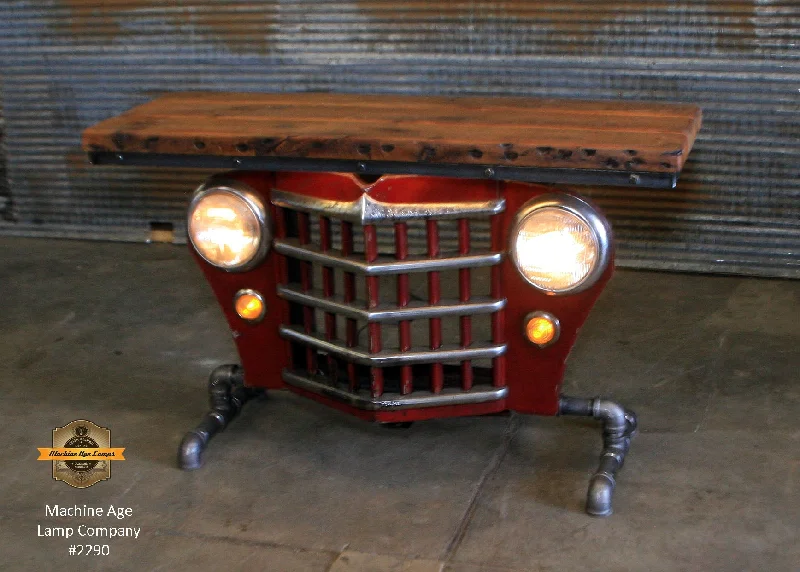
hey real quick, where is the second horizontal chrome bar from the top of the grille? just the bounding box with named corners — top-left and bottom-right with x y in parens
top-left (273, 239), bottom-right (503, 276)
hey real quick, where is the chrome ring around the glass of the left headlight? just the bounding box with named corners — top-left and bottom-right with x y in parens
top-left (186, 177), bottom-right (272, 272)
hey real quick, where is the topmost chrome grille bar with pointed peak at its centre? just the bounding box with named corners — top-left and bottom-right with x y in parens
top-left (272, 189), bottom-right (506, 224)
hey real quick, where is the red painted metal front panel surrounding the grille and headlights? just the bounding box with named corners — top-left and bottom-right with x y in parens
top-left (196, 172), bottom-right (613, 421)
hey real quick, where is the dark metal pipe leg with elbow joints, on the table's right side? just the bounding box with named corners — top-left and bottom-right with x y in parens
top-left (559, 395), bottom-right (638, 516)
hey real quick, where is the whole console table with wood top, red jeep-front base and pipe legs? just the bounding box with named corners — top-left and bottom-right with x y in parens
top-left (83, 93), bottom-right (701, 516)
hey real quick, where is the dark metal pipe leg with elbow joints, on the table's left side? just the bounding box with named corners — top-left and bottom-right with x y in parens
top-left (178, 365), bottom-right (263, 470)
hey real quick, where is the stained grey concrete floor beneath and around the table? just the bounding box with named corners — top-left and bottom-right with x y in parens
top-left (0, 239), bottom-right (800, 572)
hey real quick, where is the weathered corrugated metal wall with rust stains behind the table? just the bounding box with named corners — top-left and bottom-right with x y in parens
top-left (0, 0), bottom-right (800, 277)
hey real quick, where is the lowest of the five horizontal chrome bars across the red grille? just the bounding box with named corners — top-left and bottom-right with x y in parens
top-left (282, 370), bottom-right (508, 411)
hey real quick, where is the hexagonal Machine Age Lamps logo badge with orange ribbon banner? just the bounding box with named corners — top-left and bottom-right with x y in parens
top-left (38, 419), bottom-right (125, 489)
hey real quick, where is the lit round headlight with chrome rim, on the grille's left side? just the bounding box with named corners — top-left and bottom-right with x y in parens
top-left (188, 178), bottom-right (271, 271)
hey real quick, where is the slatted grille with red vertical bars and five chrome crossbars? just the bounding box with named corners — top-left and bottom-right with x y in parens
top-left (272, 191), bottom-right (506, 409)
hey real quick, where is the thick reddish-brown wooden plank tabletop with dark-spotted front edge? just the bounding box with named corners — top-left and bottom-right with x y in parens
top-left (83, 92), bottom-right (701, 173)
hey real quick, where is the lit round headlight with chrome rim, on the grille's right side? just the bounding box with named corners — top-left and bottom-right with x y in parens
top-left (510, 195), bottom-right (610, 294)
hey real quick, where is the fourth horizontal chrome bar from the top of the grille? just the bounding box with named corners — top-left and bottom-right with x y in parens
top-left (278, 326), bottom-right (506, 367)
